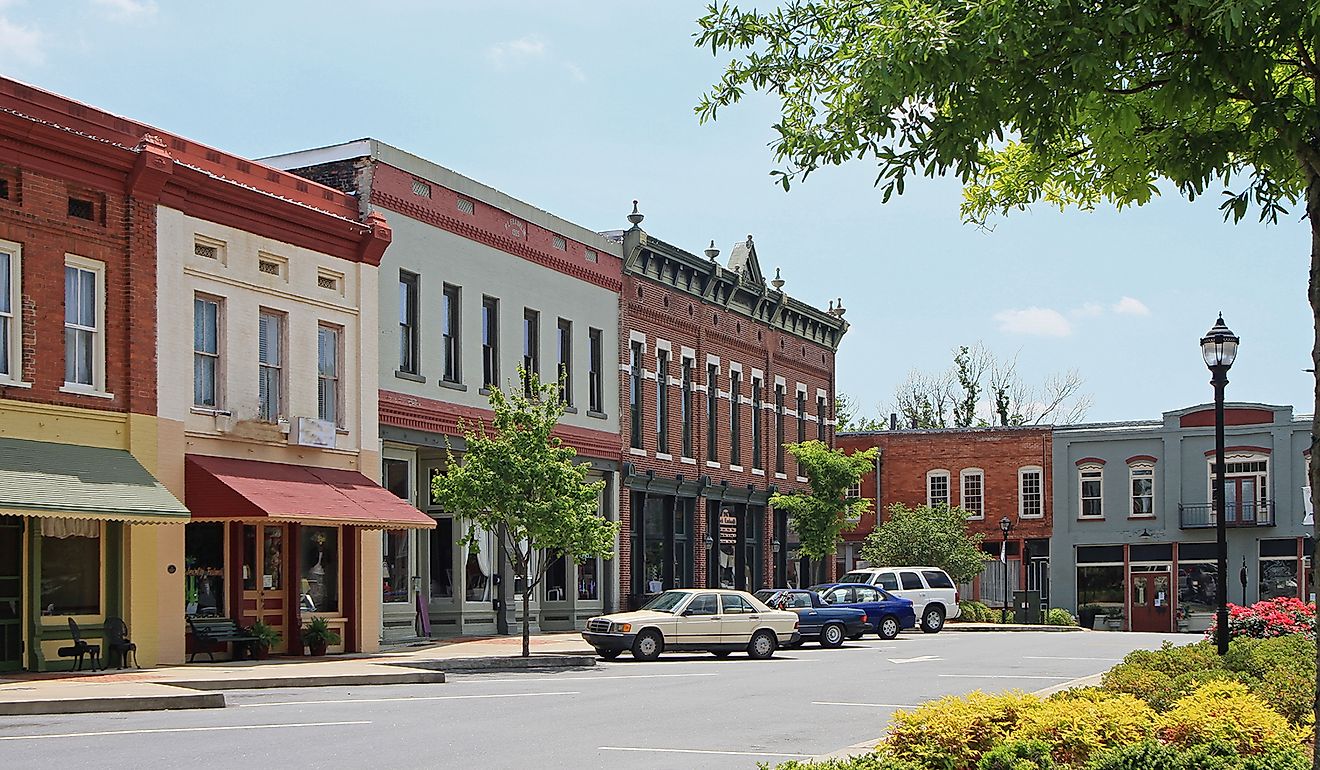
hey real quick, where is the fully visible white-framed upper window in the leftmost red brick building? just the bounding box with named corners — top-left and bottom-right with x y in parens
top-left (65, 256), bottom-right (106, 391)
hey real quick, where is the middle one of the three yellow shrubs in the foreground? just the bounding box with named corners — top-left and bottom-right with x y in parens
top-left (1012, 688), bottom-right (1156, 766)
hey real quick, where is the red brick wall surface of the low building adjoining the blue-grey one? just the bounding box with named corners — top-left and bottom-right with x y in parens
top-left (838, 428), bottom-right (1053, 602)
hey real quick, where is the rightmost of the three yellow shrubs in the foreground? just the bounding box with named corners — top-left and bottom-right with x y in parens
top-left (1156, 682), bottom-right (1302, 754)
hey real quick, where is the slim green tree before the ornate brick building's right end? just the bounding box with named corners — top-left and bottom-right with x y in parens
top-left (770, 441), bottom-right (878, 580)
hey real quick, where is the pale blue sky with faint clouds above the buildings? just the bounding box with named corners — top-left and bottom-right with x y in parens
top-left (0, 0), bottom-right (1312, 420)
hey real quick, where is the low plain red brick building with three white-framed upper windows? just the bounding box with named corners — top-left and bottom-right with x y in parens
top-left (837, 427), bottom-right (1053, 606)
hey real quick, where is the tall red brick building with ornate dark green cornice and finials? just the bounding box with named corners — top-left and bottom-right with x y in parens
top-left (609, 205), bottom-right (847, 605)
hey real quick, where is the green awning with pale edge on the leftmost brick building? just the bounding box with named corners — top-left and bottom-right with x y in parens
top-left (0, 438), bottom-right (189, 523)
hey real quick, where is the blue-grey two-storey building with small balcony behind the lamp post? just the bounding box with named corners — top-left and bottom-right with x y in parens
top-left (1051, 403), bottom-right (1313, 631)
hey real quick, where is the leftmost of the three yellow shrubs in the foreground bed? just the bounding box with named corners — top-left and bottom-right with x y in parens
top-left (882, 691), bottom-right (1041, 770)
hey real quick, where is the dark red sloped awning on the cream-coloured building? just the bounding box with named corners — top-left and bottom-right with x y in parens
top-left (183, 454), bottom-right (436, 530)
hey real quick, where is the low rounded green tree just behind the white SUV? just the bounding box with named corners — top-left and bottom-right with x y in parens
top-left (862, 503), bottom-right (990, 582)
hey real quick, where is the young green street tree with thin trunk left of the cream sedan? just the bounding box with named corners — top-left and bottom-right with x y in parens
top-left (432, 374), bottom-right (619, 658)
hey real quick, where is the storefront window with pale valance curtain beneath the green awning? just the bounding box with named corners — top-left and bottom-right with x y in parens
top-left (41, 519), bottom-right (100, 615)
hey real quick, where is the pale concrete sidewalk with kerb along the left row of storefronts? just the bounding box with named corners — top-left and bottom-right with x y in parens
top-left (0, 633), bottom-right (595, 716)
